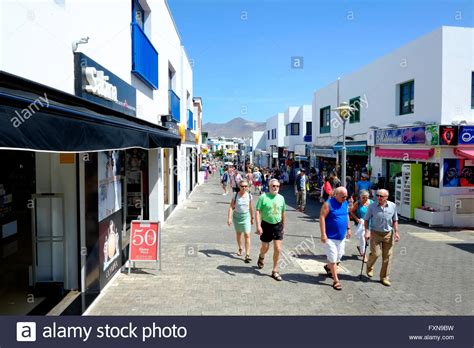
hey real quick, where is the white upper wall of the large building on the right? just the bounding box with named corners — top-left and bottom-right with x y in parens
top-left (313, 27), bottom-right (473, 146)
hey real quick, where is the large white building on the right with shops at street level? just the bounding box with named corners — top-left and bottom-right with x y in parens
top-left (313, 27), bottom-right (474, 226)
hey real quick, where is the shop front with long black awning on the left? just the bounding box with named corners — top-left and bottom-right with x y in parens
top-left (0, 72), bottom-right (180, 314)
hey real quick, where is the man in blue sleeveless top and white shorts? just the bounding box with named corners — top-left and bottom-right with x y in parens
top-left (319, 186), bottom-right (351, 290)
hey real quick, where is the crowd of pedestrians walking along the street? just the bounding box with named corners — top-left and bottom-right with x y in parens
top-left (219, 162), bottom-right (400, 290)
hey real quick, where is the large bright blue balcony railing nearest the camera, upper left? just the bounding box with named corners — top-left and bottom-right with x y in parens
top-left (132, 23), bottom-right (158, 89)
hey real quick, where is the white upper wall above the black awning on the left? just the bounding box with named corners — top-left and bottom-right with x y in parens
top-left (0, 0), bottom-right (193, 123)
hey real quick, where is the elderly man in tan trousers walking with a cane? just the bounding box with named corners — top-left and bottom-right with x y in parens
top-left (364, 190), bottom-right (400, 286)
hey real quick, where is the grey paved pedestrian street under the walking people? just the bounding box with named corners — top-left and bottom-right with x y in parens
top-left (86, 177), bottom-right (474, 315)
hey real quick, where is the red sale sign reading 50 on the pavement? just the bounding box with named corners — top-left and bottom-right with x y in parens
top-left (129, 220), bottom-right (161, 261)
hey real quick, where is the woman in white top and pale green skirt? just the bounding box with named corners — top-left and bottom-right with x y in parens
top-left (227, 180), bottom-right (255, 263)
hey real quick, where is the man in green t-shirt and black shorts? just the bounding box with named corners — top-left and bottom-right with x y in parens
top-left (256, 179), bottom-right (286, 281)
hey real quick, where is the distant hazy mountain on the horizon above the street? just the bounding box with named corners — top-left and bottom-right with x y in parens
top-left (202, 117), bottom-right (266, 138)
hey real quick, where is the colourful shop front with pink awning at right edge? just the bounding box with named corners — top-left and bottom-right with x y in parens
top-left (371, 125), bottom-right (474, 227)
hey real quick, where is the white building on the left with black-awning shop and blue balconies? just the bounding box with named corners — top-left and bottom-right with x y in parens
top-left (0, 0), bottom-right (199, 314)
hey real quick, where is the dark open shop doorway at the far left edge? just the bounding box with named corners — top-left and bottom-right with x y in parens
top-left (0, 151), bottom-right (36, 315)
